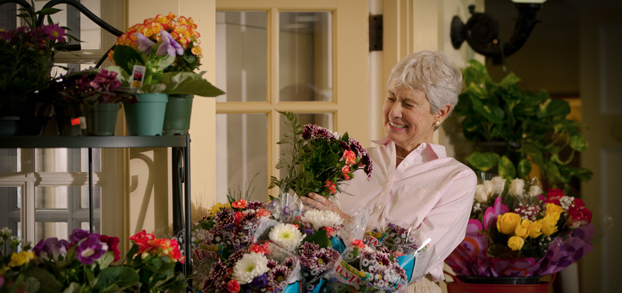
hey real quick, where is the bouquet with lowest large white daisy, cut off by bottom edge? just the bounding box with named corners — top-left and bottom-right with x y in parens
top-left (201, 243), bottom-right (297, 293)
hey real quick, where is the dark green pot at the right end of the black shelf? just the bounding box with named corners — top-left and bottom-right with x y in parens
top-left (162, 95), bottom-right (194, 135)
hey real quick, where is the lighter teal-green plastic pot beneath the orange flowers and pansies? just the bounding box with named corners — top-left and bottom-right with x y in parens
top-left (123, 93), bottom-right (168, 136)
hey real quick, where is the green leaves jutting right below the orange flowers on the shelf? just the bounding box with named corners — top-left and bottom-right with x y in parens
top-left (160, 72), bottom-right (225, 97)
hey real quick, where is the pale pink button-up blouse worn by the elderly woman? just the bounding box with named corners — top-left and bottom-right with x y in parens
top-left (334, 138), bottom-right (477, 281)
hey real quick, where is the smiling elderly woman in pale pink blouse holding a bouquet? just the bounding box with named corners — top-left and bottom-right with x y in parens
top-left (303, 51), bottom-right (477, 292)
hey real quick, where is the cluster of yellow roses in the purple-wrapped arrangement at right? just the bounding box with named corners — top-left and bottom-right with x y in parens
top-left (497, 203), bottom-right (564, 251)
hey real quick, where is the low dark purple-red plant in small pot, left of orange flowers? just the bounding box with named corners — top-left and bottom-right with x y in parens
top-left (60, 67), bottom-right (138, 107)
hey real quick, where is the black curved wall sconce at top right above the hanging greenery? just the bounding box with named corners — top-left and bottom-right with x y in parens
top-left (450, 0), bottom-right (546, 64)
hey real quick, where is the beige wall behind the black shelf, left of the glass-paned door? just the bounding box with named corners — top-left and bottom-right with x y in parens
top-left (125, 0), bottom-right (216, 236)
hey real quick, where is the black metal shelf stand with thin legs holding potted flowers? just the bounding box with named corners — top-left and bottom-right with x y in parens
top-left (0, 135), bottom-right (192, 284)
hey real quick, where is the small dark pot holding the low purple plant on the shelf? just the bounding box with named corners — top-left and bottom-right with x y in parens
top-left (82, 103), bottom-right (120, 136)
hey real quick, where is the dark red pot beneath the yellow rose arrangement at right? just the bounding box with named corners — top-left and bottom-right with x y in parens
top-left (445, 272), bottom-right (555, 293)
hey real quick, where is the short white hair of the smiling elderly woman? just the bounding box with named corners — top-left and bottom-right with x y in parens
top-left (387, 51), bottom-right (462, 114)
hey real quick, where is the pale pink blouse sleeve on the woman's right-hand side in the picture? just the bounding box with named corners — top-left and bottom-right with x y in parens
top-left (416, 169), bottom-right (477, 282)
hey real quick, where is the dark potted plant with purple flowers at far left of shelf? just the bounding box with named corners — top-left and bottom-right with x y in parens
top-left (0, 1), bottom-right (71, 135)
